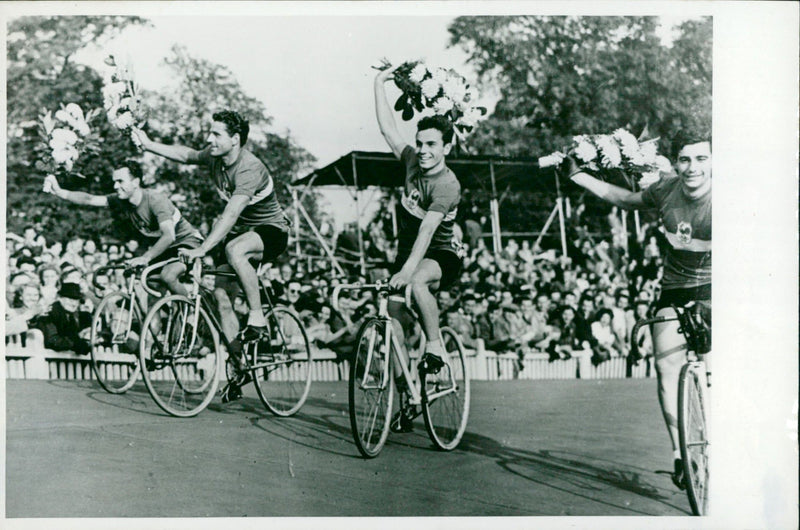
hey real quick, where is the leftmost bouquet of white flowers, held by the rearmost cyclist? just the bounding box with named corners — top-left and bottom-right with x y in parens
top-left (35, 103), bottom-right (99, 184)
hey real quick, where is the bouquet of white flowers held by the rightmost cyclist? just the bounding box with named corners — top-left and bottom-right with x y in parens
top-left (539, 129), bottom-right (664, 185)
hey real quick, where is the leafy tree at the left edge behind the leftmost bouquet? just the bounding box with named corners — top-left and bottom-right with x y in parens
top-left (6, 16), bottom-right (147, 239)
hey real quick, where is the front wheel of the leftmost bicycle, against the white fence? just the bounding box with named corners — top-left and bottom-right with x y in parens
top-left (90, 291), bottom-right (142, 394)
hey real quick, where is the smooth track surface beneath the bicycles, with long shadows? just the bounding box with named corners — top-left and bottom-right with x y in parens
top-left (5, 380), bottom-right (689, 518)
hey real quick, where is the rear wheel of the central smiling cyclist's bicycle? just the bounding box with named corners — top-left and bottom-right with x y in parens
top-left (420, 328), bottom-right (470, 451)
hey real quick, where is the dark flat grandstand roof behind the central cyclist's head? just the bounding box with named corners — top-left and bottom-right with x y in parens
top-left (292, 151), bottom-right (556, 193)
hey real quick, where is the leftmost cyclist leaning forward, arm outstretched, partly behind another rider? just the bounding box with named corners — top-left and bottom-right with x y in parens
top-left (44, 160), bottom-right (203, 297)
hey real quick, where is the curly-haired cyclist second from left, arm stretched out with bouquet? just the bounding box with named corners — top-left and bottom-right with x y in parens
top-left (133, 110), bottom-right (289, 402)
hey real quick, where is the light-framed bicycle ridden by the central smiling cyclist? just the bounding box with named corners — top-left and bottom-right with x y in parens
top-left (331, 282), bottom-right (470, 458)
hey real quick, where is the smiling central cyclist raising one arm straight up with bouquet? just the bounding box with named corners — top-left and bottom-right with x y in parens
top-left (374, 68), bottom-right (462, 431)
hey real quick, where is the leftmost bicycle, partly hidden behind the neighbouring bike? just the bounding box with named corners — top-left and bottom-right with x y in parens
top-left (89, 259), bottom-right (175, 394)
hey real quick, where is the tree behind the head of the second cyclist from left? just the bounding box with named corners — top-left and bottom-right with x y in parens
top-left (145, 46), bottom-right (316, 231)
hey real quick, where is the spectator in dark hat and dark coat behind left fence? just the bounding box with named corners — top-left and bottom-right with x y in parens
top-left (33, 283), bottom-right (92, 355)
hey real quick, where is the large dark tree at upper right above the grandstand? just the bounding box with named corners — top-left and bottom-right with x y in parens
top-left (449, 16), bottom-right (712, 235)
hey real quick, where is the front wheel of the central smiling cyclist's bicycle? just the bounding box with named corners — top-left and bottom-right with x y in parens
top-left (348, 318), bottom-right (394, 458)
